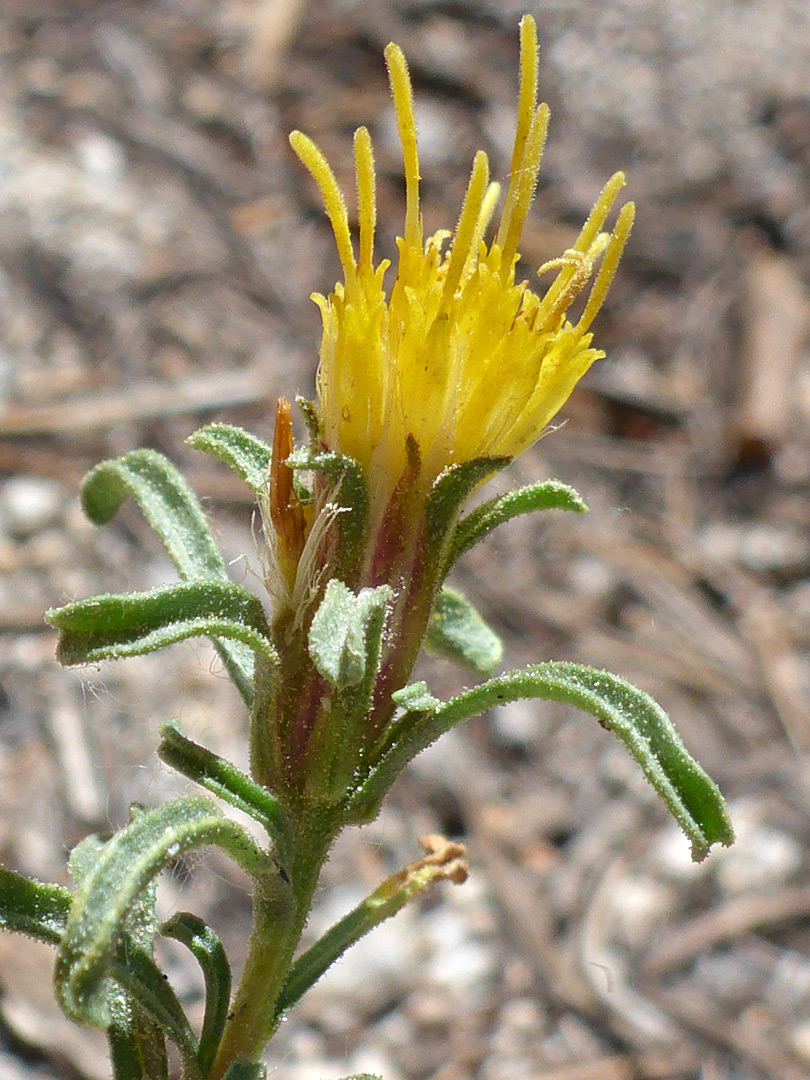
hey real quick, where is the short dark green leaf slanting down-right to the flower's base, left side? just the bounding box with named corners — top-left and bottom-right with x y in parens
top-left (158, 721), bottom-right (293, 866)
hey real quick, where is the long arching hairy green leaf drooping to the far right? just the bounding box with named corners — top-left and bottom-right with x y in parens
top-left (349, 661), bottom-right (733, 862)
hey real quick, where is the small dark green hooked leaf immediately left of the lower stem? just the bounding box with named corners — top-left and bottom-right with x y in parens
top-left (160, 912), bottom-right (231, 1077)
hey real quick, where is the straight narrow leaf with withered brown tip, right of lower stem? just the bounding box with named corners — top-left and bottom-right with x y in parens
top-left (276, 837), bottom-right (468, 1016)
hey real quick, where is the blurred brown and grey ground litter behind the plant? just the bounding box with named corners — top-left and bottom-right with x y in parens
top-left (0, 0), bottom-right (810, 1080)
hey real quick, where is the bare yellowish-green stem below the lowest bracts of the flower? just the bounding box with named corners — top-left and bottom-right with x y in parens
top-left (210, 822), bottom-right (335, 1080)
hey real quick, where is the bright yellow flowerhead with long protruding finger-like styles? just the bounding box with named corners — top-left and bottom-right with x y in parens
top-left (289, 15), bottom-right (633, 505)
